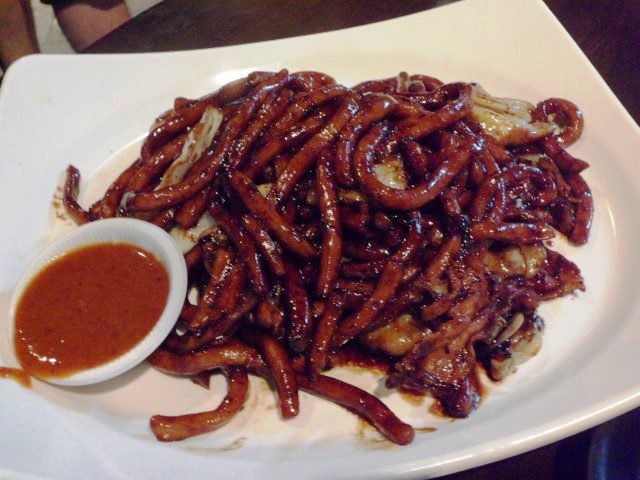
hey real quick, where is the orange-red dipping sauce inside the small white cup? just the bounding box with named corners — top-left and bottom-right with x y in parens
top-left (14, 243), bottom-right (169, 378)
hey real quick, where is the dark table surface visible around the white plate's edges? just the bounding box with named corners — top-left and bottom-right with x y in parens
top-left (86, 0), bottom-right (640, 480)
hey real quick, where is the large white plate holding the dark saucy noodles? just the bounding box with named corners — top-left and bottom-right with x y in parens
top-left (0, 0), bottom-right (640, 480)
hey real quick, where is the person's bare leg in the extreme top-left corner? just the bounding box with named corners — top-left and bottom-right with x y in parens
top-left (0, 0), bottom-right (38, 69)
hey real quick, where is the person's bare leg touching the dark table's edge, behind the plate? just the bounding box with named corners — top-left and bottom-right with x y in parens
top-left (54, 0), bottom-right (131, 52)
